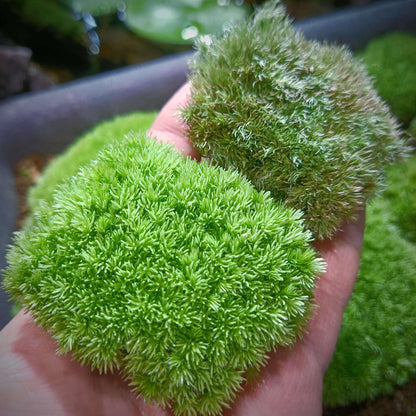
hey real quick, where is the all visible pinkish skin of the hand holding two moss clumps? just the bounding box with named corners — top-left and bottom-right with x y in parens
top-left (0, 85), bottom-right (365, 416)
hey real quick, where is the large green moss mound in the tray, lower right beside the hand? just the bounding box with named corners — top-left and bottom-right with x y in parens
top-left (324, 199), bottom-right (416, 405)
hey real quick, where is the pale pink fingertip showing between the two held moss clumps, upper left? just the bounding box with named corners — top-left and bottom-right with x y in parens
top-left (148, 83), bottom-right (200, 160)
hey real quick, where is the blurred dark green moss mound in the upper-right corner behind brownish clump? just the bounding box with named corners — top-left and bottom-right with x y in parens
top-left (361, 33), bottom-right (416, 124)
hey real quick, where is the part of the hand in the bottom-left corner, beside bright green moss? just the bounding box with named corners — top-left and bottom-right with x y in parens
top-left (0, 311), bottom-right (171, 416)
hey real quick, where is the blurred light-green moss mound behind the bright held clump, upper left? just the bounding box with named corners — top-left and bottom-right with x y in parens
top-left (28, 112), bottom-right (157, 212)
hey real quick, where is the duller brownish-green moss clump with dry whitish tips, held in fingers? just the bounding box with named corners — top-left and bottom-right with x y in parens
top-left (182, 2), bottom-right (405, 238)
